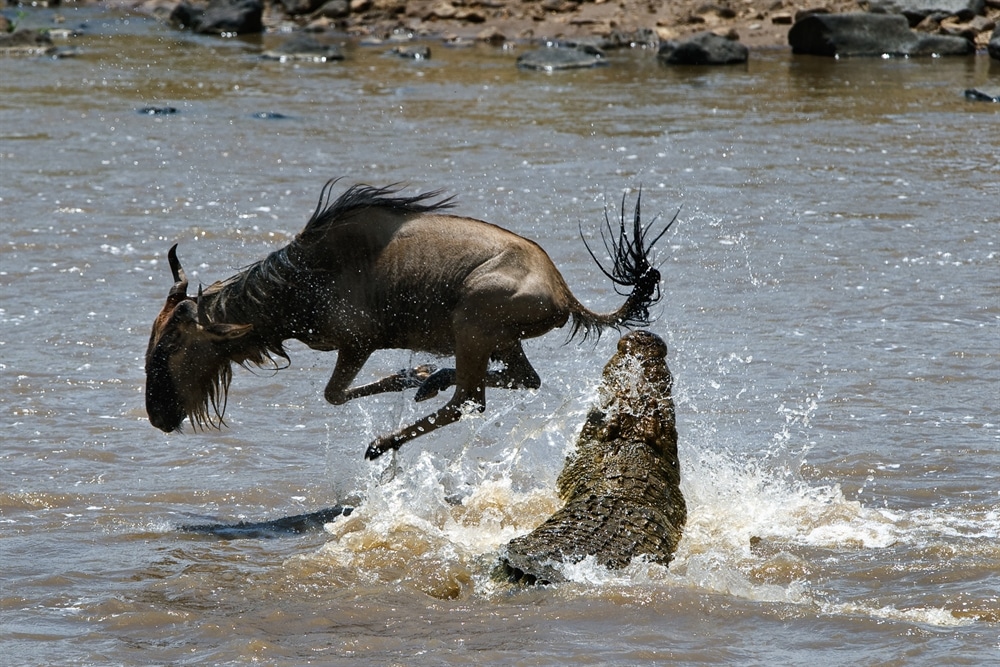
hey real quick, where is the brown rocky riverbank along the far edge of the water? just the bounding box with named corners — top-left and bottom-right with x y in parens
top-left (0, 0), bottom-right (1000, 51)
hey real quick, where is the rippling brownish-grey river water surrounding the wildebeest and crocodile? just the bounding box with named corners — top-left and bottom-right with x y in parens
top-left (0, 9), bottom-right (1000, 666)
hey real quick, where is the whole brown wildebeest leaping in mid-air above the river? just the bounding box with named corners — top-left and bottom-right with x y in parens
top-left (146, 181), bottom-right (677, 459)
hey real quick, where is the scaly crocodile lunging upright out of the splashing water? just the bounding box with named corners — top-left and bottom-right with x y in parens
top-left (498, 331), bottom-right (687, 584)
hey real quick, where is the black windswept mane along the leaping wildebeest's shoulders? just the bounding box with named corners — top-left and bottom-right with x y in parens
top-left (294, 178), bottom-right (455, 247)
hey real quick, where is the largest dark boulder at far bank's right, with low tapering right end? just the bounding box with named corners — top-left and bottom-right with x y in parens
top-left (788, 13), bottom-right (975, 57)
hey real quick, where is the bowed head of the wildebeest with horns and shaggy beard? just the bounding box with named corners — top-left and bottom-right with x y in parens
top-left (146, 245), bottom-right (252, 433)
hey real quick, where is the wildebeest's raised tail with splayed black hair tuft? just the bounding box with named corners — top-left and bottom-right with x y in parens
top-left (570, 189), bottom-right (677, 338)
